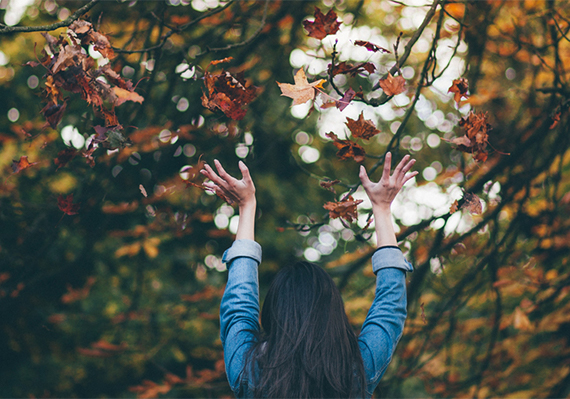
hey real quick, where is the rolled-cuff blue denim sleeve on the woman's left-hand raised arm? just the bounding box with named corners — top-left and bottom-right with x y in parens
top-left (220, 240), bottom-right (261, 395)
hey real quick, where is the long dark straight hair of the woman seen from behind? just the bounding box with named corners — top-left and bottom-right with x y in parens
top-left (246, 262), bottom-right (366, 398)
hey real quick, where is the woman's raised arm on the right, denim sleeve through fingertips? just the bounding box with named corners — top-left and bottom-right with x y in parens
top-left (358, 153), bottom-right (417, 395)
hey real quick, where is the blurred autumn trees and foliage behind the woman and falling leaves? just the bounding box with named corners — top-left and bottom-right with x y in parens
top-left (0, 0), bottom-right (570, 398)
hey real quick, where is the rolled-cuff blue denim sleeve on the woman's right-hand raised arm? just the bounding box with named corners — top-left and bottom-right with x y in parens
top-left (358, 247), bottom-right (414, 397)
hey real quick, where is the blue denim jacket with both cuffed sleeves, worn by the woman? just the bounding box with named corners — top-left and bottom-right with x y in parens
top-left (220, 240), bottom-right (413, 398)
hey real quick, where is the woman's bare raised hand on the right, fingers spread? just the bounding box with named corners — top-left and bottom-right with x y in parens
top-left (359, 152), bottom-right (418, 210)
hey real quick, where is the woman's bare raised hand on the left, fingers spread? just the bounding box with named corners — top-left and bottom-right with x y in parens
top-left (200, 159), bottom-right (256, 208)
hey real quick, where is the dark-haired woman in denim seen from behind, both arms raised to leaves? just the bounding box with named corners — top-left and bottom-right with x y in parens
top-left (201, 153), bottom-right (417, 398)
